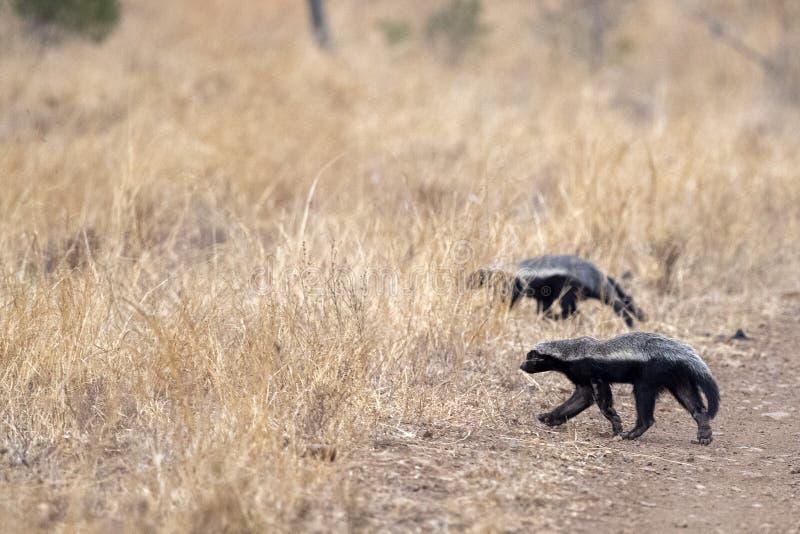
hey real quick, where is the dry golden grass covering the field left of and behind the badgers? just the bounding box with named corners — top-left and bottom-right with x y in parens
top-left (0, 0), bottom-right (800, 531)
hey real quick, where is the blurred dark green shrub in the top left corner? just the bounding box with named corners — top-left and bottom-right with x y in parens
top-left (12, 0), bottom-right (120, 41)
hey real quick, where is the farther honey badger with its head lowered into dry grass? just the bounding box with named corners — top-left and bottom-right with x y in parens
top-left (470, 255), bottom-right (645, 327)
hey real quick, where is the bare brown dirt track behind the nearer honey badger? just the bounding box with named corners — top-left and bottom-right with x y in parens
top-left (580, 314), bottom-right (800, 532)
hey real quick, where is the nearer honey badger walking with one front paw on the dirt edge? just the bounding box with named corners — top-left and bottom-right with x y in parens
top-left (520, 332), bottom-right (719, 445)
